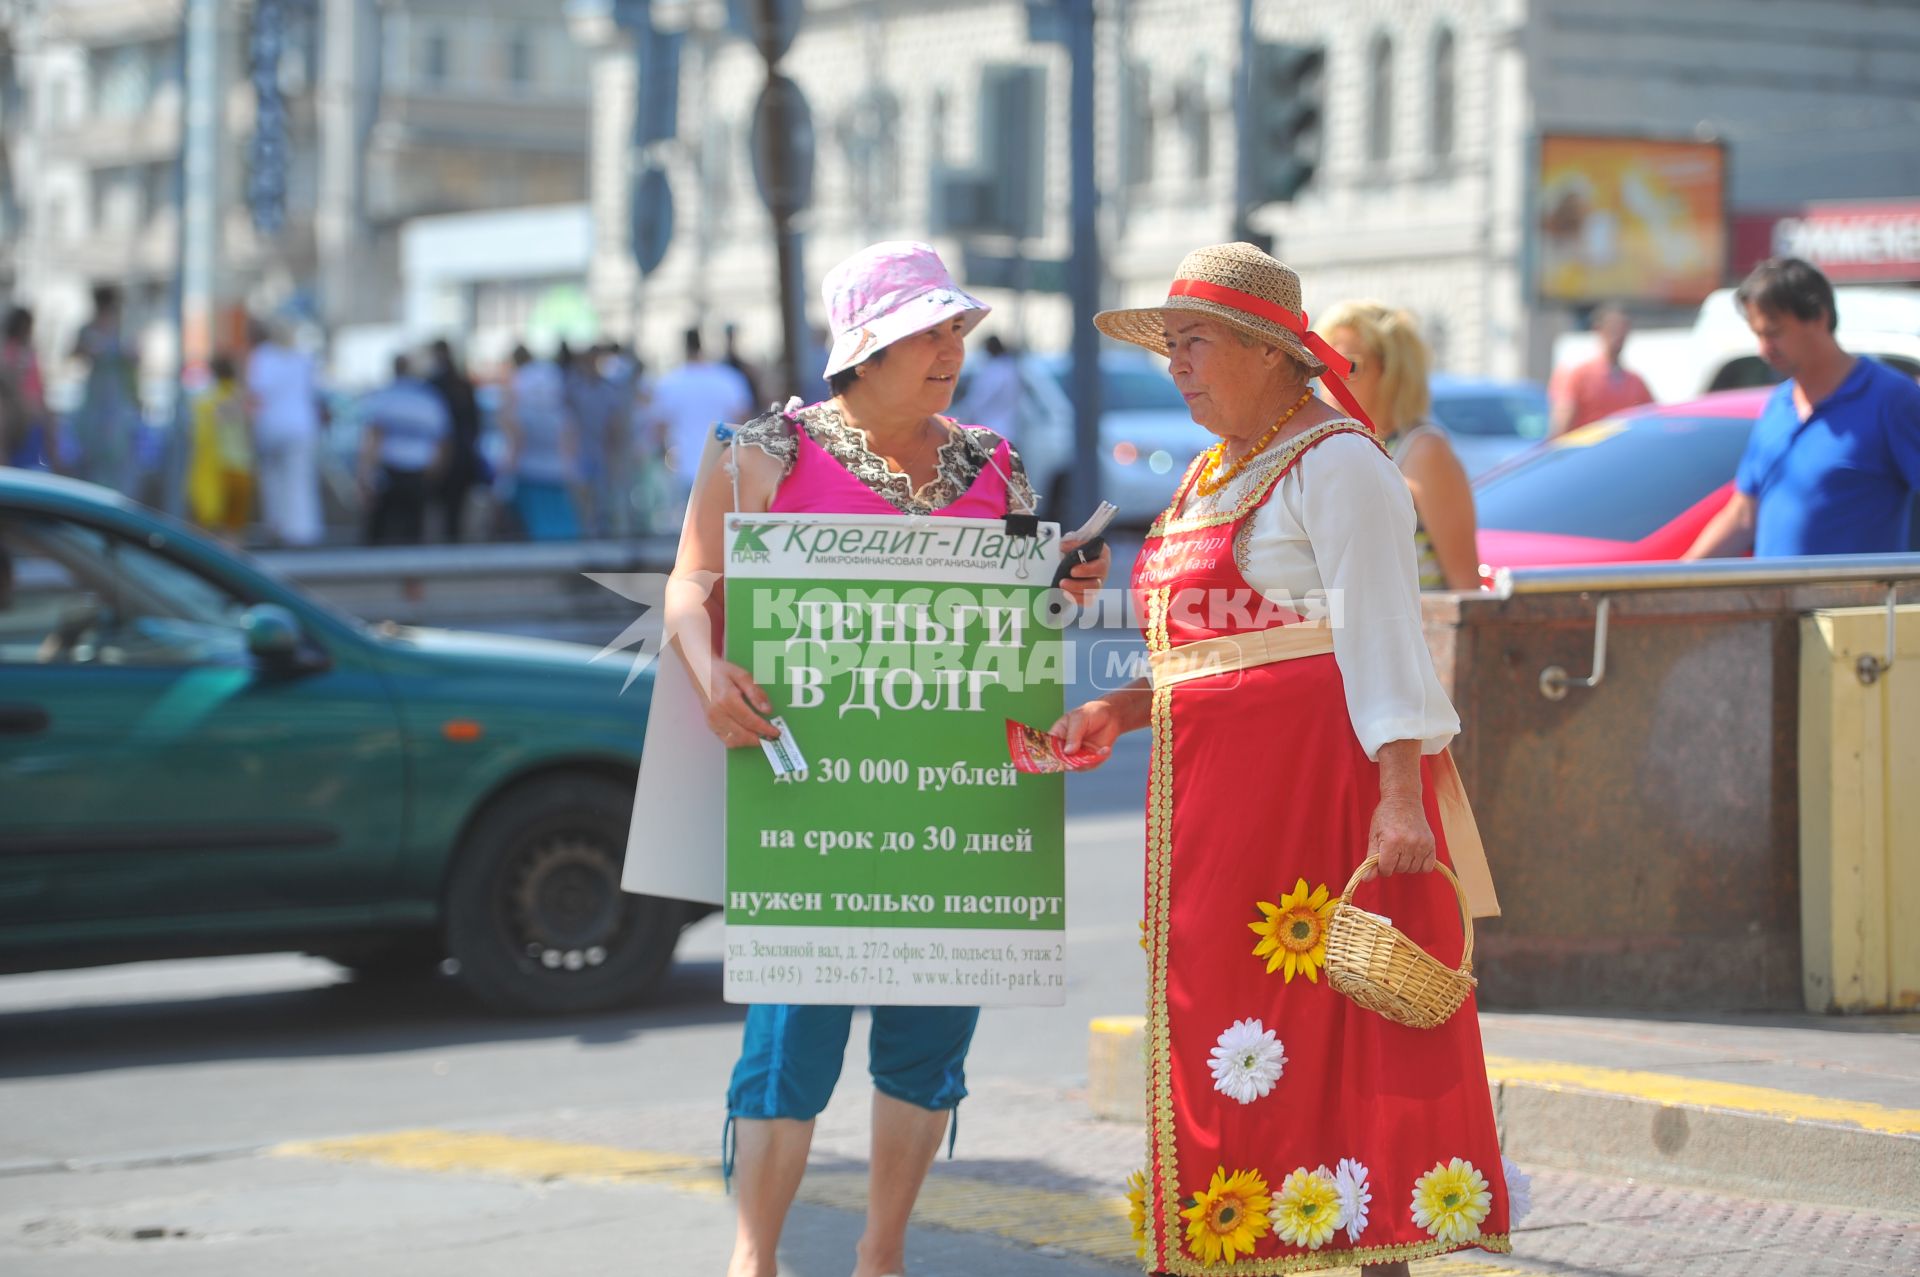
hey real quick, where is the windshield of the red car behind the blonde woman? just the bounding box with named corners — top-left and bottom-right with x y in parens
top-left (1473, 417), bottom-right (1753, 542)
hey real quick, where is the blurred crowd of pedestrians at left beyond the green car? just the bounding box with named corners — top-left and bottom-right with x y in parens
top-left (0, 309), bottom-right (787, 547)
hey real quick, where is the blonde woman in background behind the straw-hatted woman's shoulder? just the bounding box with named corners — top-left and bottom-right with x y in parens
top-left (1315, 301), bottom-right (1480, 590)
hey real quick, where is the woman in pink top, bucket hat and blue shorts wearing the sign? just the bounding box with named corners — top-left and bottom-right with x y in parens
top-left (666, 242), bottom-right (1110, 1277)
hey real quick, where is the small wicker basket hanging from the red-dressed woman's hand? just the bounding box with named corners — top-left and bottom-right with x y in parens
top-left (1327, 856), bottom-right (1478, 1029)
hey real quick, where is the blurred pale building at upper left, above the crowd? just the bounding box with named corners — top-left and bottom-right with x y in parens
top-left (0, 0), bottom-right (589, 394)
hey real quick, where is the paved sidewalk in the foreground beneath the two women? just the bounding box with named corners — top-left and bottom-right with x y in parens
top-left (0, 1077), bottom-right (1920, 1277)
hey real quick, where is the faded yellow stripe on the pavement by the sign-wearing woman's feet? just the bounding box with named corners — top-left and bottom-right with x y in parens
top-left (269, 1131), bottom-right (1536, 1277)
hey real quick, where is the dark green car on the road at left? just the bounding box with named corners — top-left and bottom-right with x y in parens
top-left (0, 469), bottom-right (695, 1012)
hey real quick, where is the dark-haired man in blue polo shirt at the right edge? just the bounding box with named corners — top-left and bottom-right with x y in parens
top-left (1682, 257), bottom-right (1920, 559)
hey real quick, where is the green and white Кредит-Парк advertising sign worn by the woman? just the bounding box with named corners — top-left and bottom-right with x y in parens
top-left (726, 515), bottom-right (1066, 1006)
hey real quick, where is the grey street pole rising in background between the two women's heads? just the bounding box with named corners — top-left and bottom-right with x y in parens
top-left (1048, 0), bottom-right (1100, 528)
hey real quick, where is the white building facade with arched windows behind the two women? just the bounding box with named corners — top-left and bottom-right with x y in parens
top-left (574, 0), bottom-right (1920, 378)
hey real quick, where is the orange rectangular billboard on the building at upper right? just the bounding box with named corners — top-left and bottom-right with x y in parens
top-left (1536, 134), bottom-right (1726, 303)
